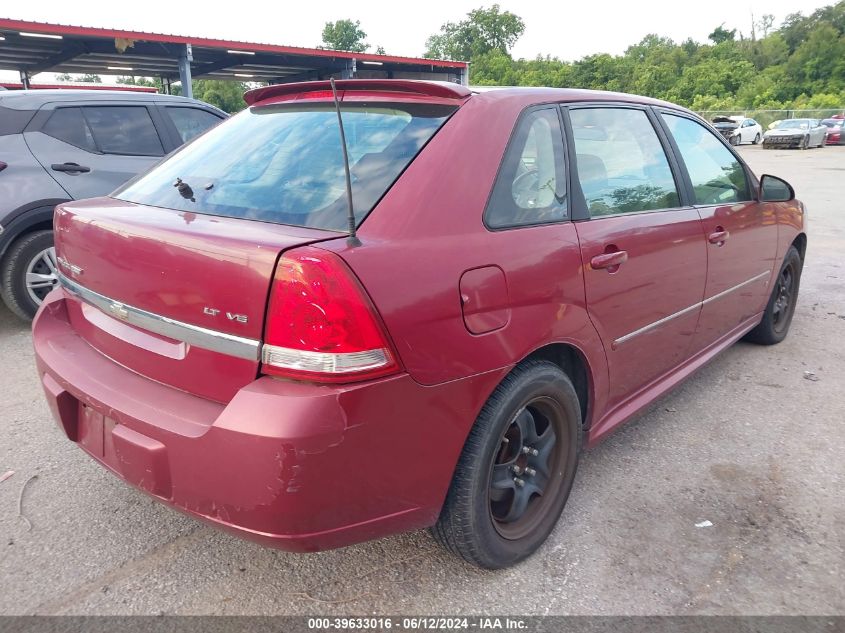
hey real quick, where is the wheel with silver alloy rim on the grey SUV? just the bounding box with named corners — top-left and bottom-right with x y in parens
top-left (0, 231), bottom-right (58, 321)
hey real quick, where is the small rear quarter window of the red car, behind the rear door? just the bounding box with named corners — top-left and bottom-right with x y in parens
top-left (485, 108), bottom-right (567, 228)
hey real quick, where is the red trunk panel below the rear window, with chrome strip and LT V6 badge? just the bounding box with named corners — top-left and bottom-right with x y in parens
top-left (55, 198), bottom-right (337, 402)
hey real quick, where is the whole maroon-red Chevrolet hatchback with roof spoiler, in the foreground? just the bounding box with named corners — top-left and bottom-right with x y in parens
top-left (33, 80), bottom-right (807, 568)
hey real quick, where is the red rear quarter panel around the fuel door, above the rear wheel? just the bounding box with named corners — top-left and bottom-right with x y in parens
top-left (321, 95), bottom-right (607, 421)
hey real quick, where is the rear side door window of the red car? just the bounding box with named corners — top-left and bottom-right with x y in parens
top-left (569, 108), bottom-right (680, 216)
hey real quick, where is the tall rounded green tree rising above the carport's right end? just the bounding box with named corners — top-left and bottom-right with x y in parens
top-left (425, 4), bottom-right (525, 61)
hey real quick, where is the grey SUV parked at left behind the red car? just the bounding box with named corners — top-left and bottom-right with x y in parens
top-left (0, 90), bottom-right (226, 319)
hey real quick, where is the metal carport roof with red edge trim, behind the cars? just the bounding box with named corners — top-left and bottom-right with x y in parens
top-left (0, 18), bottom-right (468, 96)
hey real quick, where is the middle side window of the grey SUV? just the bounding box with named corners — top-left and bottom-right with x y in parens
top-left (83, 106), bottom-right (164, 156)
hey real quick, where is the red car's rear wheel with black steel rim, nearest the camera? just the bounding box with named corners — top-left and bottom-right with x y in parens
top-left (432, 361), bottom-right (582, 569)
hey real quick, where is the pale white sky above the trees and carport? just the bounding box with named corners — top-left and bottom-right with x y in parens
top-left (0, 0), bottom-right (835, 80)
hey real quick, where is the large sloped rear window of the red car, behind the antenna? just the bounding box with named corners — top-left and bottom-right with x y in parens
top-left (114, 103), bottom-right (455, 230)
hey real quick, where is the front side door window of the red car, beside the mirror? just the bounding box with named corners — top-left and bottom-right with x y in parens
top-left (662, 114), bottom-right (751, 204)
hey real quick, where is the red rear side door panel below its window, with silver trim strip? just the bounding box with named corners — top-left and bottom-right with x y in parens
top-left (576, 208), bottom-right (707, 407)
